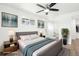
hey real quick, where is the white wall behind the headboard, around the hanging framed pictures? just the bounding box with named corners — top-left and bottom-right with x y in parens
top-left (0, 4), bottom-right (46, 50)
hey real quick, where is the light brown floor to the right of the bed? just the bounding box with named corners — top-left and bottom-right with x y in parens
top-left (59, 39), bottom-right (79, 56)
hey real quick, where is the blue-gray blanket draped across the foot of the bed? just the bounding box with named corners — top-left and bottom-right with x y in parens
top-left (23, 38), bottom-right (54, 56)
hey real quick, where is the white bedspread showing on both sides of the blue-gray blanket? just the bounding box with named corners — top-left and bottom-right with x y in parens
top-left (18, 37), bottom-right (56, 56)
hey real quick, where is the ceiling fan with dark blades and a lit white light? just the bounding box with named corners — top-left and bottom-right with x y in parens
top-left (36, 3), bottom-right (59, 15)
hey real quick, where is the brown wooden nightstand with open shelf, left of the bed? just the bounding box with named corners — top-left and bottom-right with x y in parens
top-left (3, 40), bottom-right (18, 54)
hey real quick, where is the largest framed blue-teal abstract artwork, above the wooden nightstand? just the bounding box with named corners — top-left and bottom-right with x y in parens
top-left (1, 12), bottom-right (18, 27)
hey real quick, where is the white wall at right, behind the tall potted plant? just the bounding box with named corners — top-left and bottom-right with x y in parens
top-left (53, 11), bottom-right (79, 44)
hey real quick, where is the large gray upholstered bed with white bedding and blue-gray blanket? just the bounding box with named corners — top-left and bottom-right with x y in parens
top-left (16, 31), bottom-right (62, 56)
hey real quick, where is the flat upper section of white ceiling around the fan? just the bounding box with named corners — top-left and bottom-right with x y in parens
top-left (1, 3), bottom-right (79, 17)
